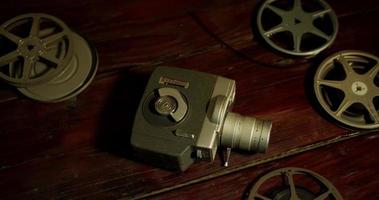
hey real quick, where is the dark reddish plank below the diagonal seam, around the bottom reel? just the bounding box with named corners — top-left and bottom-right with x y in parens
top-left (151, 135), bottom-right (379, 200)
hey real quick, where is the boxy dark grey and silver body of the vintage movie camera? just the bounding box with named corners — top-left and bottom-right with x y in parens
top-left (131, 67), bottom-right (271, 171)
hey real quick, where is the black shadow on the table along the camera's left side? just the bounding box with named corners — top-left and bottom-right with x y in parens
top-left (96, 71), bottom-right (149, 160)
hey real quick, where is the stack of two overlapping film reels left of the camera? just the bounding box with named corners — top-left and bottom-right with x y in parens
top-left (0, 13), bottom-right (98, 102)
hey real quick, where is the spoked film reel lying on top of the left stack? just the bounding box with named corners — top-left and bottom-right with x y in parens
top-left (0, 13), bottom-right (74, 87)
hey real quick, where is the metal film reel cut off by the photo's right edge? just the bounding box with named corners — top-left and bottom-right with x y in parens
top-left (313, 50), bottom-right (379, 130)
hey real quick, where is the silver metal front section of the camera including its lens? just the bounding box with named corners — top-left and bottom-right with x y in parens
top-left (195, 77), bottom-right (272, 166)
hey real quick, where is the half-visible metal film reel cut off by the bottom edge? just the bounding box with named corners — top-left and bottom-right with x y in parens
top-left (248, 167), bottom-right (342, 200)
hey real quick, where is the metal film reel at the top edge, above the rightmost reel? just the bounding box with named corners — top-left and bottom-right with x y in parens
top-left (257, 0), bottom-right (338, 56)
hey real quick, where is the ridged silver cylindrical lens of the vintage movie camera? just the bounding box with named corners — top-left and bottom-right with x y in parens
top-left (221, 112), bottom-right (272, 153)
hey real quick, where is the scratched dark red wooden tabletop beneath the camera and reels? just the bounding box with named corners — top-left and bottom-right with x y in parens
top-left (0, 0), bottom-right (379, 199)
